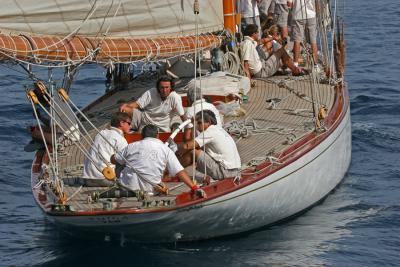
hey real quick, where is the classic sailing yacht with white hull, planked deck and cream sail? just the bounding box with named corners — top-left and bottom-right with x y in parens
top-left (0, 0), bottom-right (351, 242)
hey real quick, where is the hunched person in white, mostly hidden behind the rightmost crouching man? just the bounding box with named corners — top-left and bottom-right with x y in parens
top-left (185, 87), bottom-right (222, 141)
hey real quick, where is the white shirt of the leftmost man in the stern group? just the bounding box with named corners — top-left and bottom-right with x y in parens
top-left (82, 127), bottom-right (128, 179)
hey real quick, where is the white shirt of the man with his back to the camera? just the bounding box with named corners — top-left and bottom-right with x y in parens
top-left (115, 137), bottom-right (183, 192)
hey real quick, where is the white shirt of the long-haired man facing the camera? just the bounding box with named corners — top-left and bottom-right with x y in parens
top-left (136, 88), bottom-right (185, 132)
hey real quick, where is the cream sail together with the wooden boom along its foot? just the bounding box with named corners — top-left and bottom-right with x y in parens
top-left (0, 0), bottom-right (223, 63)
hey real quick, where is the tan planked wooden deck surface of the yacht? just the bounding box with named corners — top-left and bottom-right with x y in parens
top-left (54, 76), bottom-right (335, 211)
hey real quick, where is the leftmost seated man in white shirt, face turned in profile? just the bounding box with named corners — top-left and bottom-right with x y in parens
top-left (82, 112), bottom-right (131, 186)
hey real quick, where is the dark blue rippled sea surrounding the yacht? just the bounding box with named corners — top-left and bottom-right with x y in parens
top-left (0, 0), bottom-right (400, 267)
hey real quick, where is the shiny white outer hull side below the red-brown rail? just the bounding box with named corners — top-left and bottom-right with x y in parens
top-left (34, 84), bottom-right (351, 242)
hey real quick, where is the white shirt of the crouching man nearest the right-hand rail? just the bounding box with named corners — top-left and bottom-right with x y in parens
top-left (195, 125), bottom-right (241, 170)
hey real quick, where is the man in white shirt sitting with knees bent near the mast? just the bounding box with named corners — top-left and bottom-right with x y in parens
top-left (240, 24), bottom-right (304, 79)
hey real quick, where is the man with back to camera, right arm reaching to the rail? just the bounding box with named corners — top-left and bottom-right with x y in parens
top-left (111, 124), bottom-right (204, 196)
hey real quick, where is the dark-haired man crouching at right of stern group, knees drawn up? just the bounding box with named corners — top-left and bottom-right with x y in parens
top-left (178, 110), bottom-right (241, 181)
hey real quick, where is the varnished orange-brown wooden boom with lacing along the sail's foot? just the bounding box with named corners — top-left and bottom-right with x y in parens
top-left (0, 34), bottom-right (221, 62)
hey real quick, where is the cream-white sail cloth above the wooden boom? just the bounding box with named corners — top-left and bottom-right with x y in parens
top-left (0, 0), bottom-right (223, 37)
